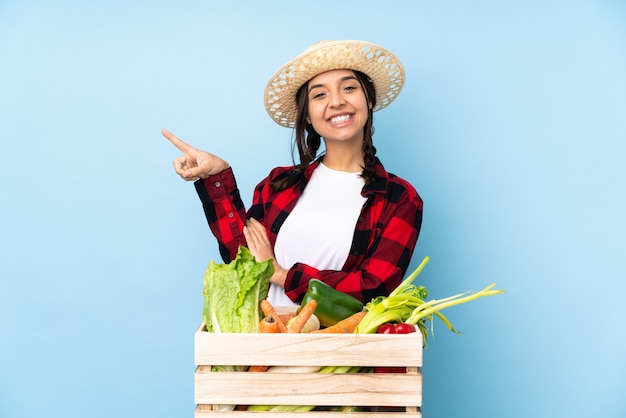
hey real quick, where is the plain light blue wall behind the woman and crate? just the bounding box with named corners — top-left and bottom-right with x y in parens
top-left (0, 0), bottom-right (626, 418)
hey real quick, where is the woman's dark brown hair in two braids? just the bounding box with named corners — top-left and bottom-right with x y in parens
top-left (272, 70), bottom-right (376, 191)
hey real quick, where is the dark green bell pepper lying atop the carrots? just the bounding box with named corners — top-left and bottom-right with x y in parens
top-left (301, 279), bottom-right (363, 327)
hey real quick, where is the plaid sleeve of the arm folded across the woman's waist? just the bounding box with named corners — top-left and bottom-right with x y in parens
top-left (285, 186), bottom-right (423, 303)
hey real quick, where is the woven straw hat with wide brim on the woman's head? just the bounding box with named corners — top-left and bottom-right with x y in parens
top-left (264, 41), bottom-right (404, 128)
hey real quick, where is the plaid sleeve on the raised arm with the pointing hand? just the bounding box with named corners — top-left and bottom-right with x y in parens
top-left (194, 167), bottom-right (246, 263)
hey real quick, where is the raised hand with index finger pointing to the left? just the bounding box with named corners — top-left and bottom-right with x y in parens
top-left (162, 129), bottom-right (229, 181)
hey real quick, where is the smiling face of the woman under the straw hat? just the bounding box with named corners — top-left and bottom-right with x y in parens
top-left (307, 70), bottom-right (371, 146)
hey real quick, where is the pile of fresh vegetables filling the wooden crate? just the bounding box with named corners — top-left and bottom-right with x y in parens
top-left (203, 247), bottom-right (504, 412)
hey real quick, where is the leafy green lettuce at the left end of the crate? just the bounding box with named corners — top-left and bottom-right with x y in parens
top-left (202, 247), bottom-right (274, 333)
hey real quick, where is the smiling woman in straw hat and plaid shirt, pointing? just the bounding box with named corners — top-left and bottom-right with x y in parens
top-left (163, 41), bottom-right (422, 306)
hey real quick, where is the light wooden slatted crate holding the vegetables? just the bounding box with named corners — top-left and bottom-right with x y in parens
top-left (194, 320), bottom-right (422, 418)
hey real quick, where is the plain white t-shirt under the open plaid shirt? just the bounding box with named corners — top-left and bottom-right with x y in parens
top-left (268, 163), bottom-right (366, 306)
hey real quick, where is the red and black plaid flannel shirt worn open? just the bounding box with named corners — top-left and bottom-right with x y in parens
top-left (195, 159), bottom-right (423, 303)
